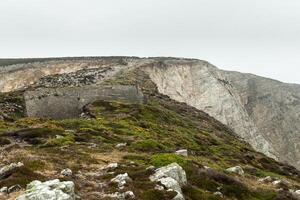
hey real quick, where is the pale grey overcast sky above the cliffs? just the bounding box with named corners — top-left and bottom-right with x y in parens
top-left (0, 0), bottom-right (300, 83)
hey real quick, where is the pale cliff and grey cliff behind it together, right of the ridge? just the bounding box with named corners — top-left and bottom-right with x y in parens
top-left (147, 59), bottom-right (300, 168)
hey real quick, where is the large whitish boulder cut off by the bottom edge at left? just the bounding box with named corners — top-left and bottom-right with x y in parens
top-left (16, 179), bottom-right (75, 200)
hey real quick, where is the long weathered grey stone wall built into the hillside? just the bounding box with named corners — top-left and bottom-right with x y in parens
top-left (24, 85), bottom-right (144, 119)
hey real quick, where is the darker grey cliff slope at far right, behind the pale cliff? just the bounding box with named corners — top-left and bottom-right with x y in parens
top-left (223, 71), bottom-right (300, 167)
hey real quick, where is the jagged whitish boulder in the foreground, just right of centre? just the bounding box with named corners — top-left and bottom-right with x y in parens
top-left (150, 163), bottom-right (187, 186)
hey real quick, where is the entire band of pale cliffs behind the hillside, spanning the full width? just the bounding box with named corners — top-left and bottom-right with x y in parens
top-left (0, 57), bottom-right (300, 168)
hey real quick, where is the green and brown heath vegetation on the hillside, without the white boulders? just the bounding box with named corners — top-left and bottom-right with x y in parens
top-left (0, 71), bottom-right (300, 200)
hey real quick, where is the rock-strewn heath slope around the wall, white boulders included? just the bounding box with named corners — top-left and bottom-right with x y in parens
top-left (0, 57), bottom-right (300, 200)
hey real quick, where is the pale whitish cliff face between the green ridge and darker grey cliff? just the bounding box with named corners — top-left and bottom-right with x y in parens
top-left (147, 61), bottom-right (277, 157)
